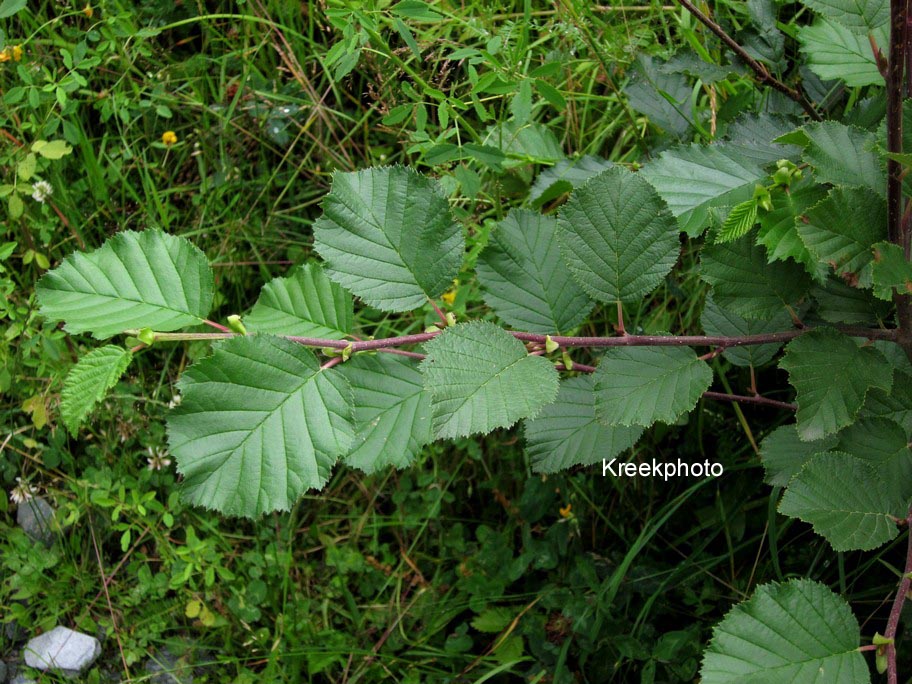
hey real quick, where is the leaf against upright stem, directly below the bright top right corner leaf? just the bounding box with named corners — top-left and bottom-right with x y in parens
top-left (802, 122), bottom-right (887, 195)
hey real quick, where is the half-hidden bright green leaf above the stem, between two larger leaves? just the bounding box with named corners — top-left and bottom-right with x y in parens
top-left (244, 264), bottom-right (354, 340)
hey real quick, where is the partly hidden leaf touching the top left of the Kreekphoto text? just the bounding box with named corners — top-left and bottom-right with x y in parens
top-left (525, 375), bottom-right (643, 473)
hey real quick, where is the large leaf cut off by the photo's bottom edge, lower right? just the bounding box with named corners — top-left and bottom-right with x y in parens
top-left (700, 579), bottom-right (870, 684)
